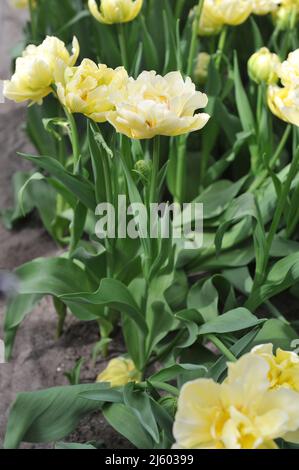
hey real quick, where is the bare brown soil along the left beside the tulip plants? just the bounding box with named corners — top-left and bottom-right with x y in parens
top-left (0, 0), bottom-right (131, 449)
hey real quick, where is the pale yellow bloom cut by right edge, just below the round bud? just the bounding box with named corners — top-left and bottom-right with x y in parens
top-left (268, 85), bottom-right (299, 126)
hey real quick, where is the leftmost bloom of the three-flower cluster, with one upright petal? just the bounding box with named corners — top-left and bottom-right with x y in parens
top-left (4, 36), bottom-right (79, 103)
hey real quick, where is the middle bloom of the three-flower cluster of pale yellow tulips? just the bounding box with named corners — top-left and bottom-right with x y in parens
top-left (57, 59), bottom-right (128, 122)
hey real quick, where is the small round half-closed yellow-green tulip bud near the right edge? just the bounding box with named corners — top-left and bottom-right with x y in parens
top-left (248, 47), bottom-right (281, 85)
